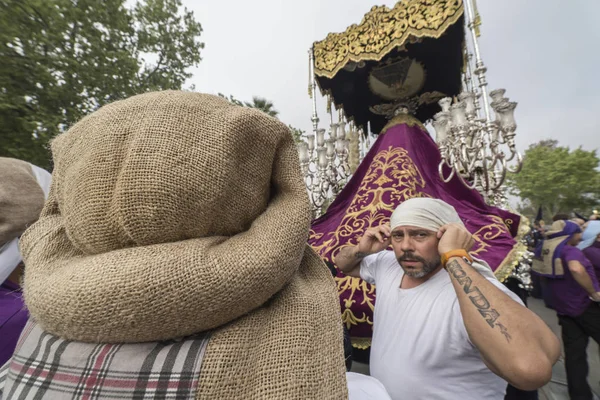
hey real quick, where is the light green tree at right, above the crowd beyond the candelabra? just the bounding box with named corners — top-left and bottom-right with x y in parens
top-left (508, 140), bottom-right (600, 216)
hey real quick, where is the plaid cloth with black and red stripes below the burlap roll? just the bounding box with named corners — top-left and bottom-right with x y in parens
top-left (0, 321), bottom-right (209, 400)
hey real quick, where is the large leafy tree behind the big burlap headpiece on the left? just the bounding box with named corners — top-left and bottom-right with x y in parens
top-left (0, 0), bottom-right (204, 168)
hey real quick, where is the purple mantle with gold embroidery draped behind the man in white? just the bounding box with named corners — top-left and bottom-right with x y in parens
top-left (309, 124), bottom-right (520, 347)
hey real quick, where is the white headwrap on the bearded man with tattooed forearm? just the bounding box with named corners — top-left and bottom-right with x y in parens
top-left (390, 198), bottom-right (496, 279)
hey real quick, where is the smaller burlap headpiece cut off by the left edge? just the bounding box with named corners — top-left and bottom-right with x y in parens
top-left (0, 157), bottom-right (44, 247)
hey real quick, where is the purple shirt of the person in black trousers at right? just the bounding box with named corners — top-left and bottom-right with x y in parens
top-left (548, 245), bottom-right (600, 317)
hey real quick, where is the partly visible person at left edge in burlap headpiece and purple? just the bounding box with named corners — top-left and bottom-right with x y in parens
top-left (0, 157), bottom-right (51, 366)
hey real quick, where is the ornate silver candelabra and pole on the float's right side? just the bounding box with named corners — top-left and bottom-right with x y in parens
top-left (433, 0), bottom-right (523, 206)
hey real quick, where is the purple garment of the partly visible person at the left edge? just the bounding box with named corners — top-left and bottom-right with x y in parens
top-left (0, 280), bottom-right (29, 365)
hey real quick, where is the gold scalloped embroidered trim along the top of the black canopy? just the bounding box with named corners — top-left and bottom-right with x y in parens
top-left (313, 0), bottom-right (464, 78)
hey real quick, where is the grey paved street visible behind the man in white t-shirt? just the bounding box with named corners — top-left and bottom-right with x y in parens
top-left (352, 298), bottom-right (600, 400)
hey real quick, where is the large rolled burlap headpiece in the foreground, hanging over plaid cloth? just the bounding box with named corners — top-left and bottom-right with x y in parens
top-left (21, 91), bottom-right (347, 399)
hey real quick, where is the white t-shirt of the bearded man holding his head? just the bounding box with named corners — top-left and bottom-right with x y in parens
top-left (360, 251), bottom-right (523, 400)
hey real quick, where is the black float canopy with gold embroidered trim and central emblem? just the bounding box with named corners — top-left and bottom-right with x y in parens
top-left (313, 0), bottom-right (464, 133)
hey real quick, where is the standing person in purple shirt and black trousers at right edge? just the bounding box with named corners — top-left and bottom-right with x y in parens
top-left (548, 221), bottom-right (600, 400)
